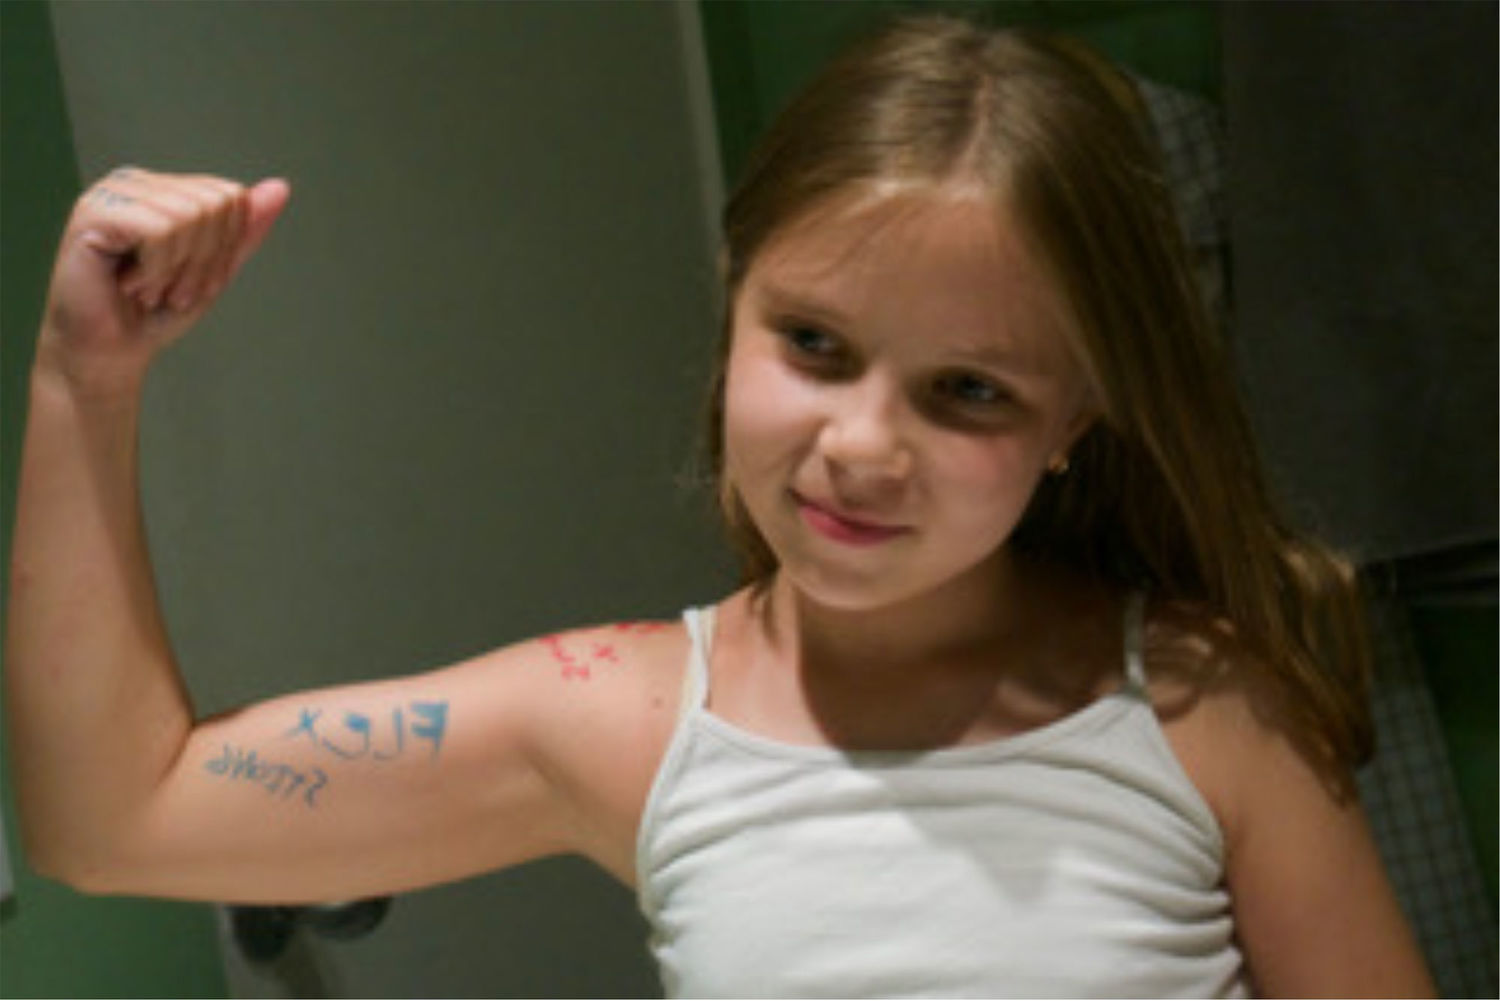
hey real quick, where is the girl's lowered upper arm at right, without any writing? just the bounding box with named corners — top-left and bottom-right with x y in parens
top-left (1163, 636), bottom-right (1434, 998)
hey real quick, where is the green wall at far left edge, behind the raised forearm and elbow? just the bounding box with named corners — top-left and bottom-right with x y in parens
top-left (0, 0), bottom-right (225, 998)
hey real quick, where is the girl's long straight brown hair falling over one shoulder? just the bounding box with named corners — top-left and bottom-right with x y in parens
top-left (707, 17), bottom-right (1371, 765)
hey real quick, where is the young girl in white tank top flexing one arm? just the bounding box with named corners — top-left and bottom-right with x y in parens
top-left (6, 18), bottom-right (1431, 996)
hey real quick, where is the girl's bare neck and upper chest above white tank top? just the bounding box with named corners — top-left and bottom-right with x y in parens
top-left (713, 557), bottom-right (1119, 750)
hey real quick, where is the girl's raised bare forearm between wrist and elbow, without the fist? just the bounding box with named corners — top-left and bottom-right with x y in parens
top-left (5, 355), bottom-right (192, 885)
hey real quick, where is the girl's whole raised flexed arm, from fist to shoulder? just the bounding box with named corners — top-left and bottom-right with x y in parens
top-left (6, 171), bottom-right (686, 902)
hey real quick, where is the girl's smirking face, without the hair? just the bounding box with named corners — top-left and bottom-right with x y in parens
top-left (725, 187), bottom-right (1092, 609)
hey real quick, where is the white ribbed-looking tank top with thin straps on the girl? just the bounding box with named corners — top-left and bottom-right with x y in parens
top-left (636, 597), bottom-right (1248, 998)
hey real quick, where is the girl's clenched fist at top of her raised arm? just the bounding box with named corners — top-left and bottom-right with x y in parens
top-left (38, 167), bottom-right (291, 392)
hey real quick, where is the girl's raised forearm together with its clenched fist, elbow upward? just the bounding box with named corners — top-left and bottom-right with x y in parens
top-left (6, 170), bottom-right (288, 884)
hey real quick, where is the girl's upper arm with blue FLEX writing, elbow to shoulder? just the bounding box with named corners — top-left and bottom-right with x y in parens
top-left (84, 627), bottom-right (687, 902)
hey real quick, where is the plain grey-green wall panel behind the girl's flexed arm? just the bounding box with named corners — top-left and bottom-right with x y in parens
top-left (53, 2), bottom-right (728, 996)
